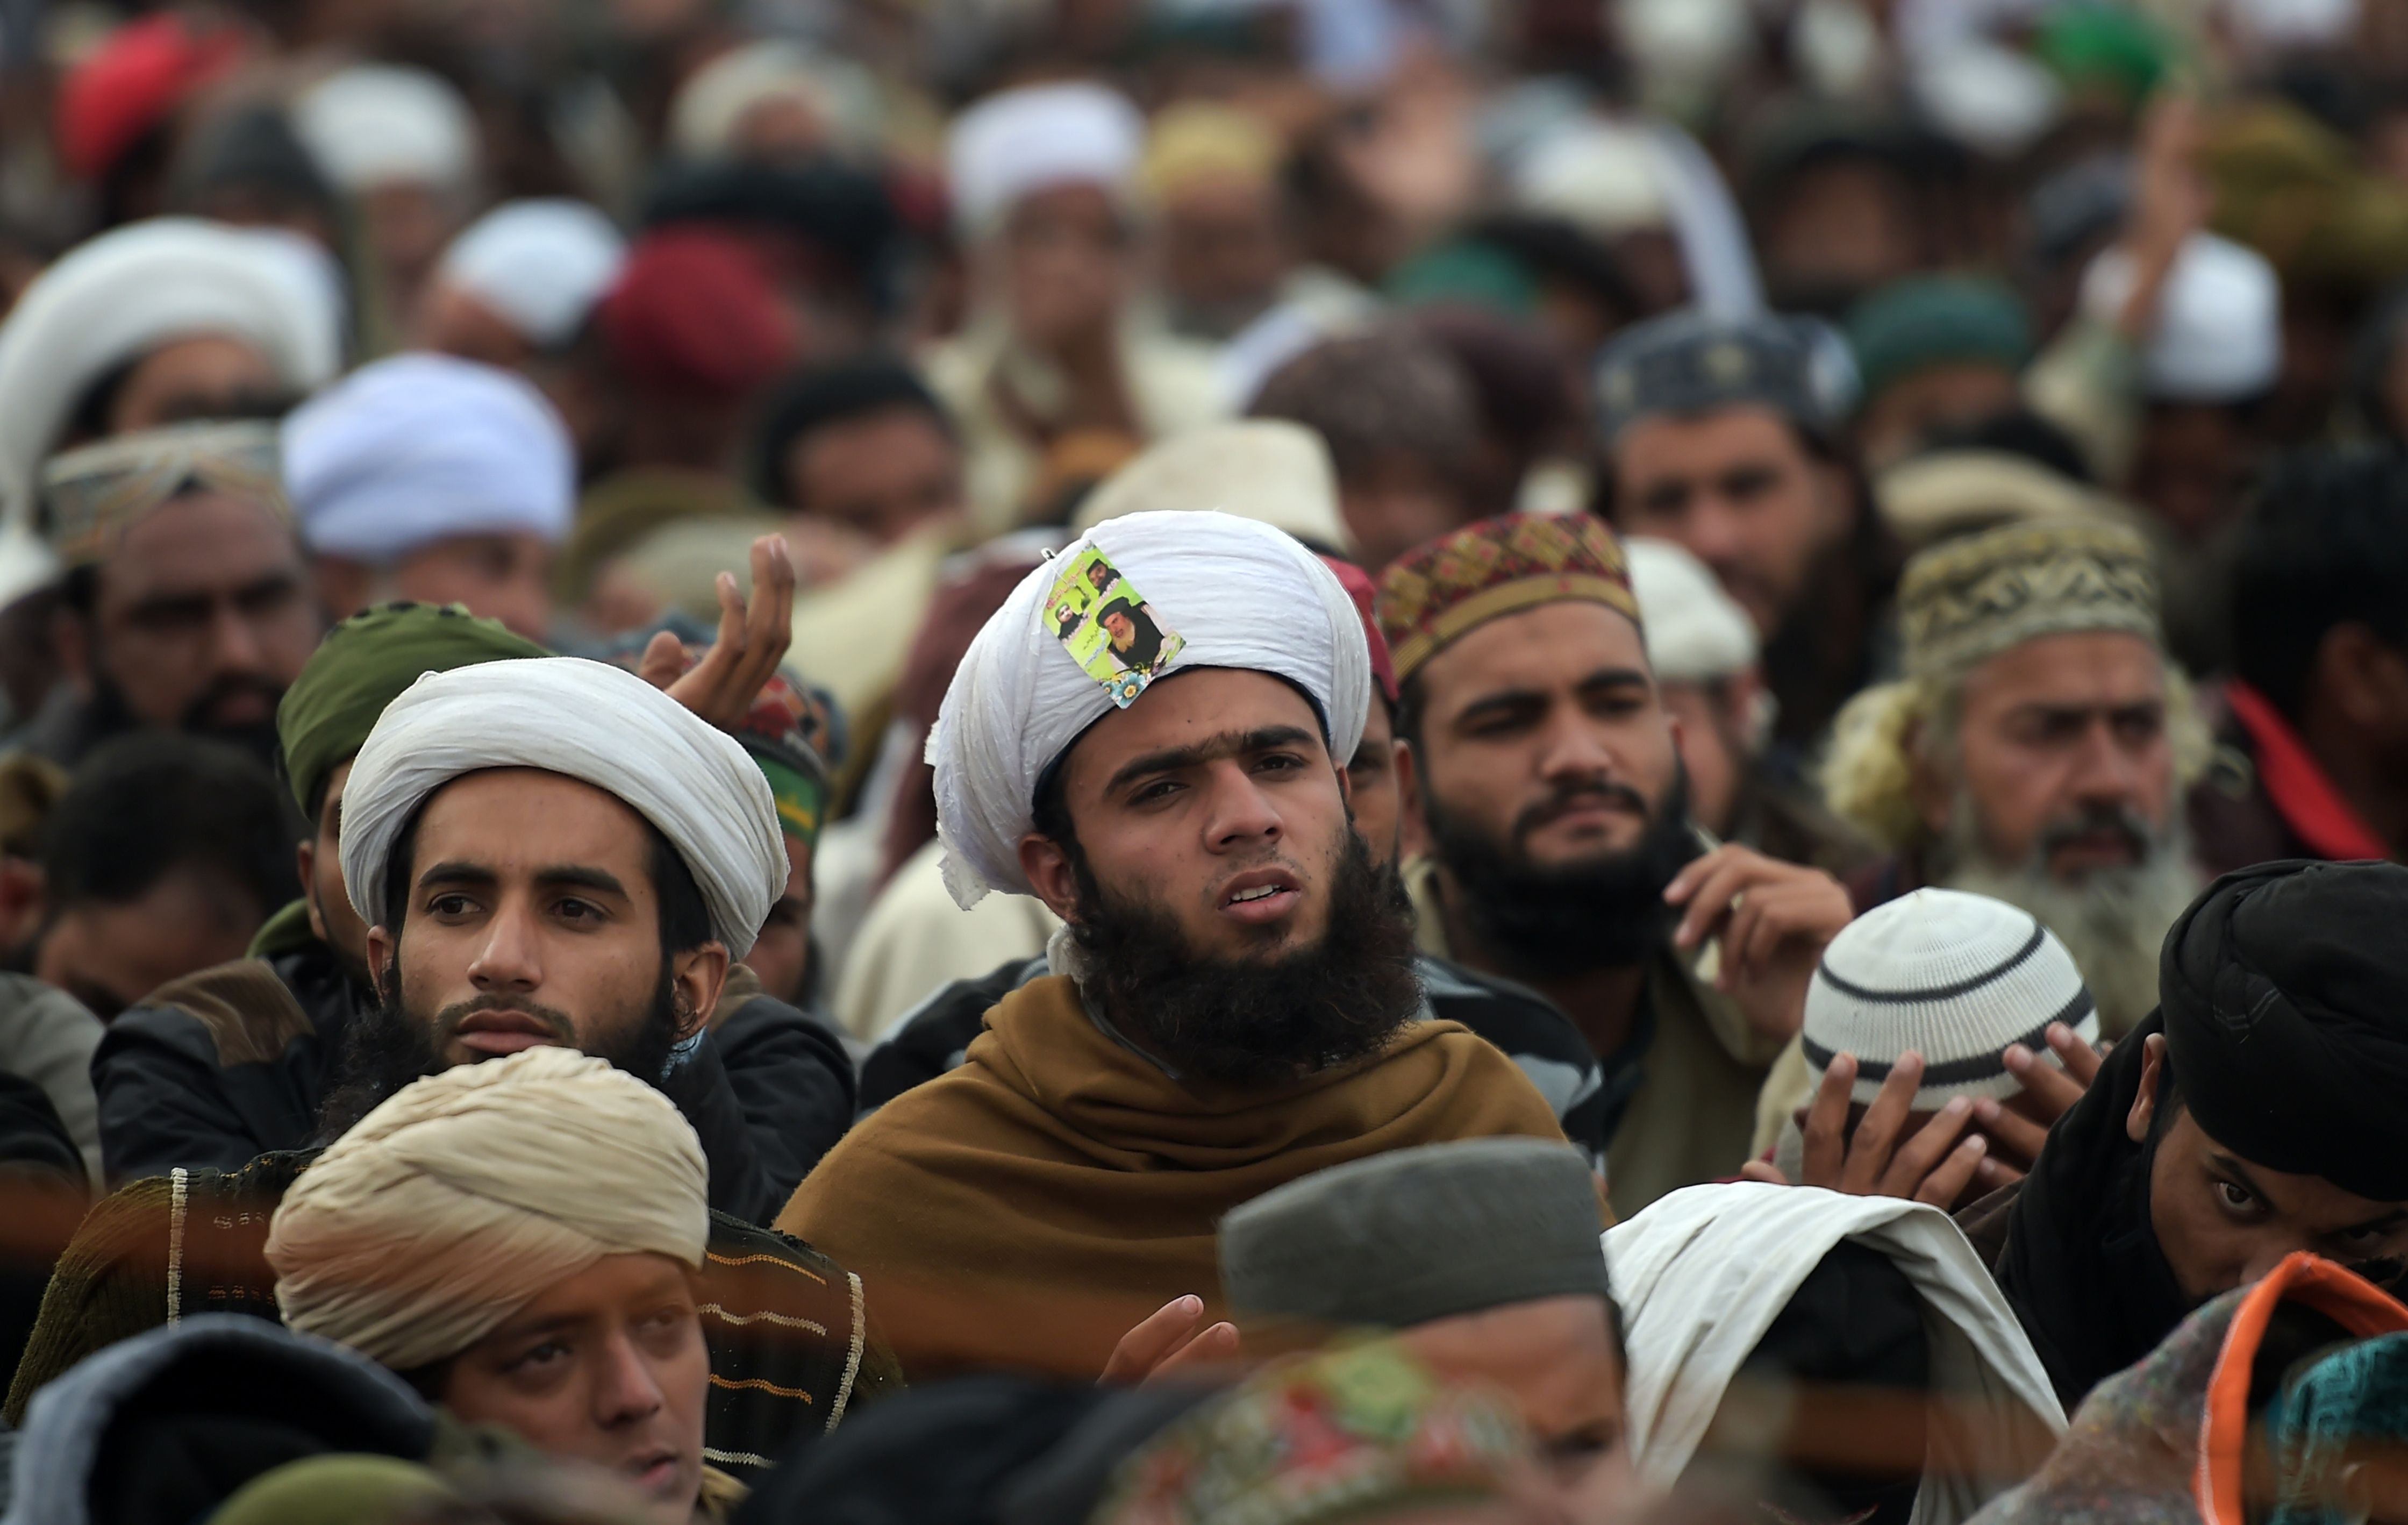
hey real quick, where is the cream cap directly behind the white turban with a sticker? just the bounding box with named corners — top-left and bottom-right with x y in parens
top-left (1069, 419), bottom-right (1356, 557)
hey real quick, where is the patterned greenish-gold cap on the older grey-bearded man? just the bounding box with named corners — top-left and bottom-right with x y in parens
top-left (1897, 521), bottom-right (2162, 677)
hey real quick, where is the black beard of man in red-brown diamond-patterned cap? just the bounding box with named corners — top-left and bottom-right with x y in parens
top-left (1423, 771), bottom-right (1705, 980)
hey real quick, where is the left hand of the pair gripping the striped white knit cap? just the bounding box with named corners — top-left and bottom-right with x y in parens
top-left (1741, 1053), bottom-right (2013, 1212)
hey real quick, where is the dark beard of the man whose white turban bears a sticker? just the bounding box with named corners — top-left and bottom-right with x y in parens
top-left (1071, 831), bottom-right (1421, 1089)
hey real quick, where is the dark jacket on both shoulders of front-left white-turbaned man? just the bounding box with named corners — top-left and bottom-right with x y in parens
top-left (91, 942), bottom-right (853, 1221)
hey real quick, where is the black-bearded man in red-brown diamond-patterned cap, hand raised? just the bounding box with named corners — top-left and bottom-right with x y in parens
top-left (1380, 513), bottom-right (1849, 1217)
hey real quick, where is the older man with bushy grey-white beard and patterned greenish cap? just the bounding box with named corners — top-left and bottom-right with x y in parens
top-left (1796, 521), bottom-right (2206, 1041)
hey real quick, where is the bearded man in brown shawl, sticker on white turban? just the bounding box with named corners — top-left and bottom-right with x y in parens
top-left (778, 513), bottom-right (1563, 1378)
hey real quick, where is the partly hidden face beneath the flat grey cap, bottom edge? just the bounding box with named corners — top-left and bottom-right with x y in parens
top-left (1397, 1296), bottom-right (1633, 1520)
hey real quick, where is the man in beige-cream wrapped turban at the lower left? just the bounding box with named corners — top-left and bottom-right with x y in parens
top-left (267, 1048), bottom-right (720, 1525)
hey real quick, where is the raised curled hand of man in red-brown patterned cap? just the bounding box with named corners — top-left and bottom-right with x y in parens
top-left (1664, 843), bottom-right (1856, 1041)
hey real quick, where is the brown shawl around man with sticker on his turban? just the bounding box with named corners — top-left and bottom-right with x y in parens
top-left (778, 976), bottom-right (1563, 1380)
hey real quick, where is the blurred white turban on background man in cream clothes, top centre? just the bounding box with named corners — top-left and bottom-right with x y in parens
top-left (944, 84), bottom-right (1146, 236)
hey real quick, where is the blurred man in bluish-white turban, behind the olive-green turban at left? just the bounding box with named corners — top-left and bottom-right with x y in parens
top-left (284, 354), bottom-right (578, 641)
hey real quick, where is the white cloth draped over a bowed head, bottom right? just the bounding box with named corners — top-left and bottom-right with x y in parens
top-left (1606, 1180), bottom-right (2066, 1525)
